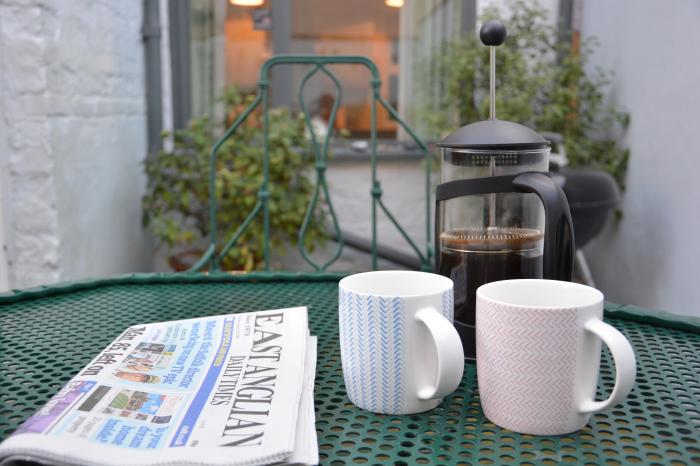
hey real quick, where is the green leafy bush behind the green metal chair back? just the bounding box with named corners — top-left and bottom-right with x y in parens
top-left (142, 87), bottom-right (328, 270)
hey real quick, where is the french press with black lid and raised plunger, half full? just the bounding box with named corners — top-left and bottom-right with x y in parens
top-left (435, 21), bottom-right (574, 360)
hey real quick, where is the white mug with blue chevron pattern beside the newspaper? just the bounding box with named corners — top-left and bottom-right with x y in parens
top-left (338, 270), bottom-right (464, 414)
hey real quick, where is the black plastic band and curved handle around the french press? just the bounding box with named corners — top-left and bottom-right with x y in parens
top-left (435, 172), bottom-right (576, 281)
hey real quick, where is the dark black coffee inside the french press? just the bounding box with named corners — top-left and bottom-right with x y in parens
top-left (439, 228), bottom-right (543, 359)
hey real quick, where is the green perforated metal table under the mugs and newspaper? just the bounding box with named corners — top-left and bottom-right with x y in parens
top-left (0, 273), bottom-right (700, 465)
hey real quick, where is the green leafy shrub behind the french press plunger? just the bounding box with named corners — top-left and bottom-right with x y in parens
top-left (418, 0), bottom-right (629, 189)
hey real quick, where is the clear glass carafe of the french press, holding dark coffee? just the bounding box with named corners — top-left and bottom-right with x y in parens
top-left (436, 147), bottom-right (549, 325)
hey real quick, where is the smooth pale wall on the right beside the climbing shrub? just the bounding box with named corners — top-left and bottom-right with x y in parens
top-left (582, 0), bottom-right (700, 315)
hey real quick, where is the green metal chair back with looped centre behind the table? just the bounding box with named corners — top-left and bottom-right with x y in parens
top-left (190, 55), bottom-right (433, 271)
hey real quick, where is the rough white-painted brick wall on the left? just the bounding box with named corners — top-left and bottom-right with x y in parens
top-left (0, 0), bottom-right (151, 287)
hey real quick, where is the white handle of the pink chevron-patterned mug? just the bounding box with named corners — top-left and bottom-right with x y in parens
top-left (579, 318), bottom-right (637, 413)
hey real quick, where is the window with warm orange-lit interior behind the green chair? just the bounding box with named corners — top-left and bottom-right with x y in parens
top-left (183, 0), bottom-right (475, 140)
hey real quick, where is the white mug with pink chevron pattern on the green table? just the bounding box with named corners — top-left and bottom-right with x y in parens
top-left (476, 279), bottom-right (637, 435)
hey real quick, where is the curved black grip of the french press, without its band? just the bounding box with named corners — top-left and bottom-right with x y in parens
top-left (513, 172), bottom-right (576, 282)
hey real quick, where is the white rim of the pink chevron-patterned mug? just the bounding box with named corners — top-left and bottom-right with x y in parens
top-left (476, 278), bottom-right (604, 310)
